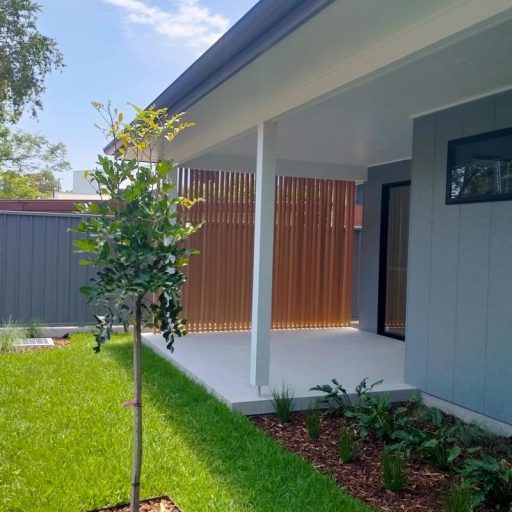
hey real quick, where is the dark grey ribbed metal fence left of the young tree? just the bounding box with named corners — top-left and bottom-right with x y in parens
top-left (0, 212), bottom-right (99, 325)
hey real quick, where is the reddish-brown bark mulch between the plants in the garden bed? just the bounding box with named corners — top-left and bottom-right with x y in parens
top-left (251, 413), bottom-right (506, 512)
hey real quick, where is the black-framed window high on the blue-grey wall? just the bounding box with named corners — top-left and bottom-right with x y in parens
top-left (446, 128), bottom-right (512, 204)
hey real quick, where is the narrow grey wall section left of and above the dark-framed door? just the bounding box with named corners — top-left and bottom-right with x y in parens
top-left (359, 160), bottom-right (411, 332)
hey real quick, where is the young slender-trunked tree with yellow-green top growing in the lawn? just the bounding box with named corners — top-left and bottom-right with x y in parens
top-left (75, 103), bottom-right (200, 512)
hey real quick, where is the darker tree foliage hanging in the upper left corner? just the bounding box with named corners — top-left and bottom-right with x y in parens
top-left (0, 0), bottom-right (63, 123)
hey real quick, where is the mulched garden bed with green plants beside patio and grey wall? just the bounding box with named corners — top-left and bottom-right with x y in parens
top-left (253, 378), bottom-right (512, 512)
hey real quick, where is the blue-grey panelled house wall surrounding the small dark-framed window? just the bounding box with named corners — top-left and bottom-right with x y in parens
top-left (406, 92), bottom-right (512, 423)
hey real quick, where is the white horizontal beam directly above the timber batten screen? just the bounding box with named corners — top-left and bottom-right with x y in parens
top-left (180, 153), bottom-right (368, 181)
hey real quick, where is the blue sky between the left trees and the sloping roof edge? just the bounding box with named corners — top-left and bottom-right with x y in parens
top-left (20, 0), bottom-right (257, 189)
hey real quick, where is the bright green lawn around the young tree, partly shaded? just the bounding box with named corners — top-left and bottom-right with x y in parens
top-left (0, 334), bottom-right (370, 512)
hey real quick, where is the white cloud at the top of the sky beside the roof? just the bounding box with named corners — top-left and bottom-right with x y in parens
top-left (103, 0), bottom-right (230, 49)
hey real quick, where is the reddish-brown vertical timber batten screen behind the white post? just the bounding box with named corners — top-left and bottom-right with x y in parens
top-left (177, 169), bottom-right (355, 332)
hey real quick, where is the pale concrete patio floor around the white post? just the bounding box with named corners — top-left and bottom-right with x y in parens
top-left (143, 327), bottom-right (414, 414)
